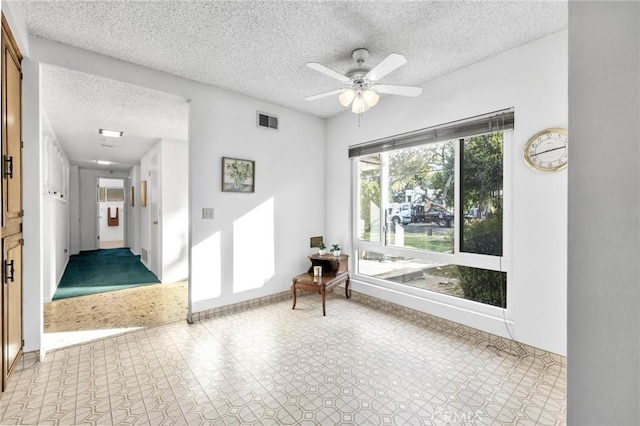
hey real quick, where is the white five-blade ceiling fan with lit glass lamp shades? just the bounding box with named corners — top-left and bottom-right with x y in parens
top-left (305, 48), bottom-right (422, 114)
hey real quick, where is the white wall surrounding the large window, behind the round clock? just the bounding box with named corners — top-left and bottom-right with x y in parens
top-left (325, 32), bottom-right (567, 354)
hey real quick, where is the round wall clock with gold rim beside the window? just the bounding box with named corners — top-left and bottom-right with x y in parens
top-left (523, 128), bottom-right (569, 172)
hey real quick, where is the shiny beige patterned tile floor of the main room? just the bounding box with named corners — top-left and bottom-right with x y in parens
top-left (0, 294), bottom-right (566, 425)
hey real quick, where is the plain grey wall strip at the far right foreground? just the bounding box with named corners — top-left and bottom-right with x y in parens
top-left (567, 2), bottom-right (640, 425)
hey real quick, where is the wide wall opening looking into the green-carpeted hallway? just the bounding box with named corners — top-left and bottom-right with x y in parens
top-left (40, 64), bottom-right (189, 357)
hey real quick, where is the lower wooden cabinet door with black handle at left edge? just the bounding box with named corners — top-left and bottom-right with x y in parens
top-left (2, 234), bottom-right (22, 387)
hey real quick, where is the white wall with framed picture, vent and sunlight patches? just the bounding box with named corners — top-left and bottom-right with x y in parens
top-left (189, 91), bottom-right (325, 312)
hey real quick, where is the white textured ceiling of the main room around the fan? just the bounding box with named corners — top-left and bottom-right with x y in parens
top-left (12, 0), bottom-right (567, 171)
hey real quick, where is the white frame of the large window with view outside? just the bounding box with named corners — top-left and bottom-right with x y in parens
top-left (351, 118), bottom-right (514, 315)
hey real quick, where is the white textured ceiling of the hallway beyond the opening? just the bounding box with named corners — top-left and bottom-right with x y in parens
top-left (41, 64), bottom-right (188, 171)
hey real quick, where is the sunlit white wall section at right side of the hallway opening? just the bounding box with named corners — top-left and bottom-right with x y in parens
top-left (160, 139), bottom-right (189, 283)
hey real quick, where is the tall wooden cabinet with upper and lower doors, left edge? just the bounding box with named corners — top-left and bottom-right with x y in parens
top-left (0, 15), bottom-right (23, 391)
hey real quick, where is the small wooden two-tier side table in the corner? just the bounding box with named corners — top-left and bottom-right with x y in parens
top-left (291, 254), bottom-right (349, 316)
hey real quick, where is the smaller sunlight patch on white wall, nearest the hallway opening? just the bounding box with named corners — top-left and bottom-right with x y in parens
top-left (191, 231), bottom-right (222, 304)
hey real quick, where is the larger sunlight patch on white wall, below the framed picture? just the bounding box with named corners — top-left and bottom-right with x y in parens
top-left (233, 198), bottom-right (275, 293)
